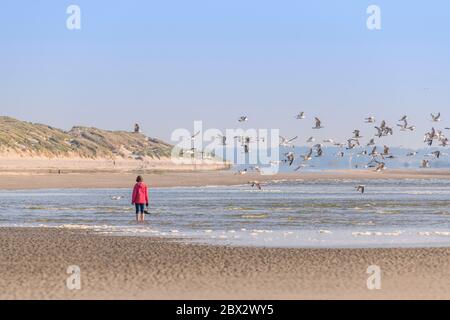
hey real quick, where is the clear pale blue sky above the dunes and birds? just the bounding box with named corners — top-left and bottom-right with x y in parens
top-left (0, 0), bottom-right (450, 147)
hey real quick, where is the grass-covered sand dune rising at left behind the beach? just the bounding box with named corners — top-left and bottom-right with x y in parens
top-left (0, 117), bottom-right (172, 159)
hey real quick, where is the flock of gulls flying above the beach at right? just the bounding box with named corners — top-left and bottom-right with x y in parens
top-left (230, 112), bottom-right (450, 193)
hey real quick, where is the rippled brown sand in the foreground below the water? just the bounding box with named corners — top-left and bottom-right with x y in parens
top-left (0, 228), bottom-right (450, 299)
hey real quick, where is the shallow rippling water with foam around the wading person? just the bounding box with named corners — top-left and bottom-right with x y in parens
top-left (0, 180), bottom-right (450, 247)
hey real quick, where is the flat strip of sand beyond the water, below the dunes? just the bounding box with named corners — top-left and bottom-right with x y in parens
top-left (0, 169), bottom-right (450, 190)
